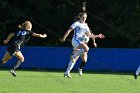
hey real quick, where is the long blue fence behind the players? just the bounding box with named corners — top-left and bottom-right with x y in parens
top-left (0, 46), bottom-right (140, 71)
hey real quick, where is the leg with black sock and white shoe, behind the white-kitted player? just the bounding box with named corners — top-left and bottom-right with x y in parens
top-left (78, 52), bottom-right (87, 76)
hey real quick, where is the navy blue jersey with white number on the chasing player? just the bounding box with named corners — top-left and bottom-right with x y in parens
top-left (9, 30), bottom-right (34, 46)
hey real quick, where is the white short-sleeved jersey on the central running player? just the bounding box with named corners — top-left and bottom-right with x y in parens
top-left (71, 21), bottom-right (89, 43)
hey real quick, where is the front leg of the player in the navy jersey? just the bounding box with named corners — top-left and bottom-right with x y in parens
top-left (10, 51), bottom-right (24, 76)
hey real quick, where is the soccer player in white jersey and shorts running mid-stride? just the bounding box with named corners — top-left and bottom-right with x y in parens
top-left (61, 12), bottom-right (104, 78)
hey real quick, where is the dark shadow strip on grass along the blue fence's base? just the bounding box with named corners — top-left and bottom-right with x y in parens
top-left (0, 67), bottom-right (133, 75)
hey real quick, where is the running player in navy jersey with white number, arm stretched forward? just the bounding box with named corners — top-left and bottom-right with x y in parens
top-left (0, 21), bottom-right (47, 77)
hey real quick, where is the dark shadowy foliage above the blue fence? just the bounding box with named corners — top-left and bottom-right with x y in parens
top-left (0, 0), bottom-right (140, 48)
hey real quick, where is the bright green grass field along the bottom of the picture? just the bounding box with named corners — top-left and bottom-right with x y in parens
top-left (0, 70), bottom-right (140, 93)
